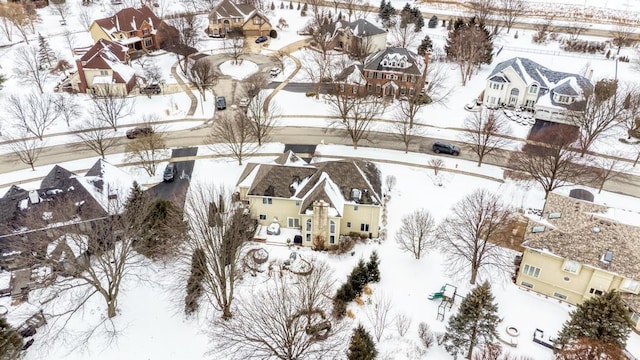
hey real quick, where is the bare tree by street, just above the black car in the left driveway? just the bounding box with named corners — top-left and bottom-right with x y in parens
top-left (125, 119), bottom-right (169, 176)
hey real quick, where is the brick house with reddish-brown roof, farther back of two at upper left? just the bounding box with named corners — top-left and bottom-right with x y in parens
top-left (89, 6), bottom-right (171, 52)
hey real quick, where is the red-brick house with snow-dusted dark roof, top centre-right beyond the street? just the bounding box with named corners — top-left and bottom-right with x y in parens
top-left (335, 47), bottom-right (429, 98)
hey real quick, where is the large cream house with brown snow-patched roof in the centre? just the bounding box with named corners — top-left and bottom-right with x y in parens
top-left (237, 151), bottom-right (381, 246)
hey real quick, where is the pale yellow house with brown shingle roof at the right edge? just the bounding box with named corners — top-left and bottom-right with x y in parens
top-left (516, 193), bottom-right (640, 330)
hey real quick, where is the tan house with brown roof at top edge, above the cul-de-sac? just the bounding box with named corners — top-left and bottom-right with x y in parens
top-left (207, 0), bottom-right (272, 36)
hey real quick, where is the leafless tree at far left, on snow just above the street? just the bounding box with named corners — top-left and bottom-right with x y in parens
top-left (6, 92), bottom-right (60, 140)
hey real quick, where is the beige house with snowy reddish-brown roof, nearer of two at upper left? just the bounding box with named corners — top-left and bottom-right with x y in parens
top-left (69, 39), bottom-right (136, 95)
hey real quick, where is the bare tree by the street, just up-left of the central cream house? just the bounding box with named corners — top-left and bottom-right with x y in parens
top-left (207, 114), bottom-right (258, 165)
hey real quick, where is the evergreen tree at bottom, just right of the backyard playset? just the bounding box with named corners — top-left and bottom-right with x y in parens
top-left (443, 282), bottom-right (500, 359)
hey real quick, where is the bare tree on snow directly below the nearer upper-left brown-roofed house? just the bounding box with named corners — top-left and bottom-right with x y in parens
top-left (91, 85), bottom-right (134, 131)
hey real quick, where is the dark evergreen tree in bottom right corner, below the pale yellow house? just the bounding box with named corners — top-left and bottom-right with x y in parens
top-left (557, 290), bottom-right (633, 349)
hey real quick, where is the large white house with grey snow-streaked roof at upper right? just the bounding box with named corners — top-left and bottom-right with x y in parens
top-left (482, 58), bottom-right (593, 125)
